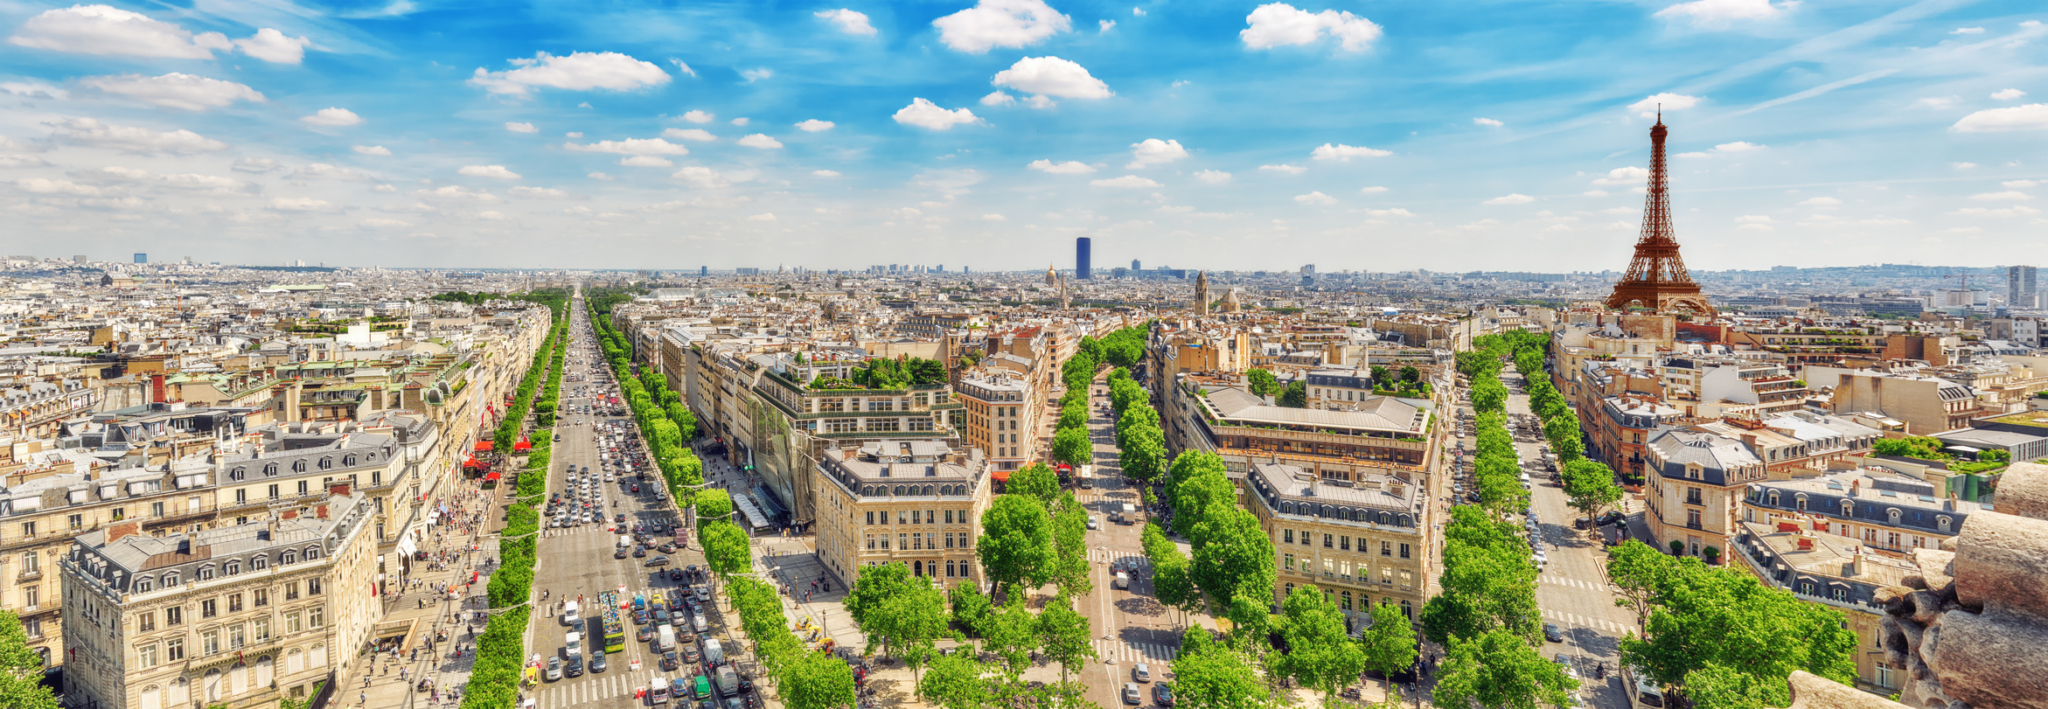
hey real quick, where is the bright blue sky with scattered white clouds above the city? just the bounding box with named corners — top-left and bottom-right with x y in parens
top-left (0, 0), bottom-right (2048, 270)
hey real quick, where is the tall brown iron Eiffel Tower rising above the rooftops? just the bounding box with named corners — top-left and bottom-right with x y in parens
top-left (1608, 111), bottom-right (1714, 318)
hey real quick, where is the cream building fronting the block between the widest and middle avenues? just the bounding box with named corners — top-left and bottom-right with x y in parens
top-left (815, 441), bottom-right (993, 586)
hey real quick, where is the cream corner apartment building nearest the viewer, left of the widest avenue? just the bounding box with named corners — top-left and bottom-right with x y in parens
top-left (59, 486), bottom-right (381, 709)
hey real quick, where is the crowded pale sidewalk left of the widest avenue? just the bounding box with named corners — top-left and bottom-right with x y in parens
top-left (334, 477), bottom-right (510, 709)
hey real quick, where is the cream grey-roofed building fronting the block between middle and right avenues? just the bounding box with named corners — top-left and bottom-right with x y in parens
top-left (1245, 463), bottom-right (1436, 627)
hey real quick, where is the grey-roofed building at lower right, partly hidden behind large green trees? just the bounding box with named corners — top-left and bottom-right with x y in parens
top-left (1729, 523), bottom-right (1919, 695)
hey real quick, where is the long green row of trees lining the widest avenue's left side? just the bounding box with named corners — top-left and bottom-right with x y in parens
top-left (463, 305), bottom-right (569, 709)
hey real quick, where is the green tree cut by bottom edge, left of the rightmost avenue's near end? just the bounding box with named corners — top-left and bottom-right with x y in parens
top-left (1432, 629), bottom-right (1579, 709)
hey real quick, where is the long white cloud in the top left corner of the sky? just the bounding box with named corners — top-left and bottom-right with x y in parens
top-left (6, 4), bottom-right (233, 59)
